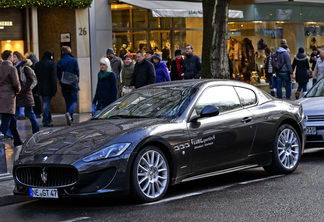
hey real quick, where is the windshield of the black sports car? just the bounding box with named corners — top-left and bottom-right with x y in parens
top-left (93, 88), bottom-right (197, 119)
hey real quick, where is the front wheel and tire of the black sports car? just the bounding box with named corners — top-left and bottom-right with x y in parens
top-left (131, 146), bottom-right (170, 203)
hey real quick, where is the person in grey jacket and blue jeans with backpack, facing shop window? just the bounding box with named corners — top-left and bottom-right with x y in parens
top-left (272, 39), bottom-right (293, 99)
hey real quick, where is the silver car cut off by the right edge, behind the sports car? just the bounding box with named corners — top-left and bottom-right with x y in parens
top-left (297, 78), bottom-right (324, 148)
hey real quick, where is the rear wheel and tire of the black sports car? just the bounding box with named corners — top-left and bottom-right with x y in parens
top-left (263, 124), bottom-right (302, 174)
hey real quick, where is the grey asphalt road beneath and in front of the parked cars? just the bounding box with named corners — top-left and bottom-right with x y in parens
top-left (0, 149), bottom-right (324, 222)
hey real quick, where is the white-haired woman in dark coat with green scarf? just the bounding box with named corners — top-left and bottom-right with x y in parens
top-left (92, 58), bottom-right (118, 110)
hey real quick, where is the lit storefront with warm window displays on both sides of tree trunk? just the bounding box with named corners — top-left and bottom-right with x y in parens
top-left (111, 0), bottom-right (324, 81)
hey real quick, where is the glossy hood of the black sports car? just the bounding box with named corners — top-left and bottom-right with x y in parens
top-left (21, 118), bottom-right (170, 156)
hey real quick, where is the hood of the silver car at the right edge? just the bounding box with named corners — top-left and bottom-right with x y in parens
top-left (297, 97), bottom-right (324, 116)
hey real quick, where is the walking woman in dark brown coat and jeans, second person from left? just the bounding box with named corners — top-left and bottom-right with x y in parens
top-left (12, 51), bottom-right (40, 133)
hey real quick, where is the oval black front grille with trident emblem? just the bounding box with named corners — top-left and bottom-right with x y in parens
top-left (15, 166), bottom-right (78, 187)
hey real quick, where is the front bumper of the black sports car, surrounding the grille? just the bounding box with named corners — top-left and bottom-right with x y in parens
top-left (13, 158), bottom-right (129, 197)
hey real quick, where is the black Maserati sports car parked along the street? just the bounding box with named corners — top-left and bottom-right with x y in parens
top-left (13, 80), bottom-right (305, 202)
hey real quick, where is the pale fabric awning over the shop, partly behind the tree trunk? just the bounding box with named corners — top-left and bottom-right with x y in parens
top-left (121, 0), bottom-right (243, 18)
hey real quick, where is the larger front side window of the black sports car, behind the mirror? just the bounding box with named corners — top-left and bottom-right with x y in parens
top-left (195, 86), bottom-right (241, 115)
